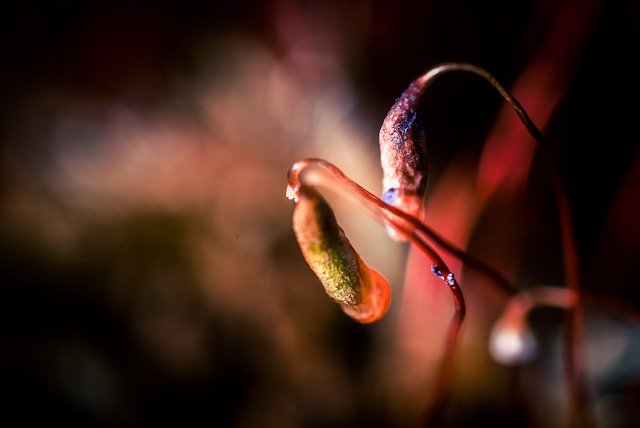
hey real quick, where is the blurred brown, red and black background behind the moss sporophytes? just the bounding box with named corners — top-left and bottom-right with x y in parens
top-left (0, 0), bottom-right (640, 427)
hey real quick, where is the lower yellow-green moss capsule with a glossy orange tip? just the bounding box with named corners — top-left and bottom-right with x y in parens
top-left (292, 188), bottom-right (390, 323)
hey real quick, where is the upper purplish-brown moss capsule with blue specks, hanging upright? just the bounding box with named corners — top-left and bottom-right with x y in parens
top-left (379, 76), bottom-right (428, 215)
